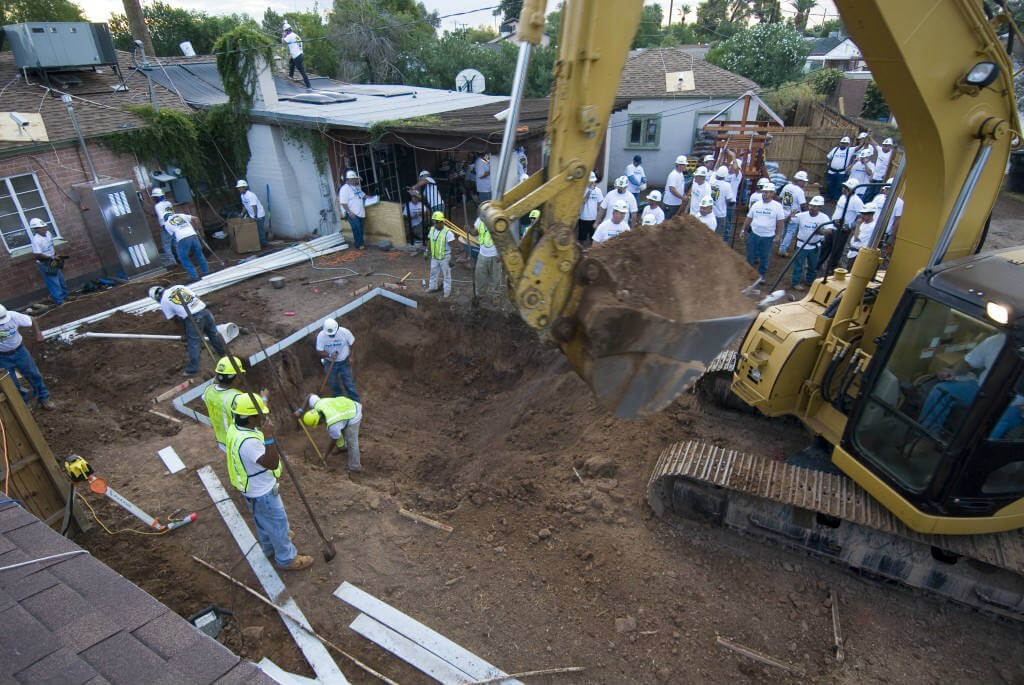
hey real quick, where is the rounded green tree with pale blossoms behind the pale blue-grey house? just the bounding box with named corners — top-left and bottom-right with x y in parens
top-left (707, 23), bottom-right (811, 88)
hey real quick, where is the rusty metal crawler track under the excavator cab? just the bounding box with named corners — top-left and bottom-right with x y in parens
top-left (647, 440), bottom-right (1024, 623)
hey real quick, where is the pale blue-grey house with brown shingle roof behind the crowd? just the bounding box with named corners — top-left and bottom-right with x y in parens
top-left (605, 47), bottom-right (760, 184)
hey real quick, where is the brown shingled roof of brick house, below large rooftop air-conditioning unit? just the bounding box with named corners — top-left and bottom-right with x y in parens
top-left (0, 50), bottom-right (188, 153)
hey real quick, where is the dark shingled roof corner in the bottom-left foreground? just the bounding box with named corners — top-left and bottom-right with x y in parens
top-left (0, 504), bottom-right (272, 685)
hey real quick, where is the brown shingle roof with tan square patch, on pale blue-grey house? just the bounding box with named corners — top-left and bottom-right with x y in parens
top-left (617, 47), bottom-right (761, 98)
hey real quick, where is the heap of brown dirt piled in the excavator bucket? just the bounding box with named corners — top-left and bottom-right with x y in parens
top-left (589, 214), bottom-right (758, 322)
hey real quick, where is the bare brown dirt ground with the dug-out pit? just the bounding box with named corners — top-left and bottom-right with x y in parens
top-left (28, 233), bottom-right (1024, 685)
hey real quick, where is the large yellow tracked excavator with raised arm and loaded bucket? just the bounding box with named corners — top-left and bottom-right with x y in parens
top-left (482, 0), bottom-right (1024, 620)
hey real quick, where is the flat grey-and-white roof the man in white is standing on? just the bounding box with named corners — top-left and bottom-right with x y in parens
top-left (150, 56), bottom-right (508, 129)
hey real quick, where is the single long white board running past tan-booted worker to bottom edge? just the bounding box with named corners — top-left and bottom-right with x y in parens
top-left (197, 465), bottom-right (348, 685)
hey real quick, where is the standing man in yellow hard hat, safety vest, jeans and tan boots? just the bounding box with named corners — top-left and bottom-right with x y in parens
top-left (226, 392), bottom-right (313, 570)
